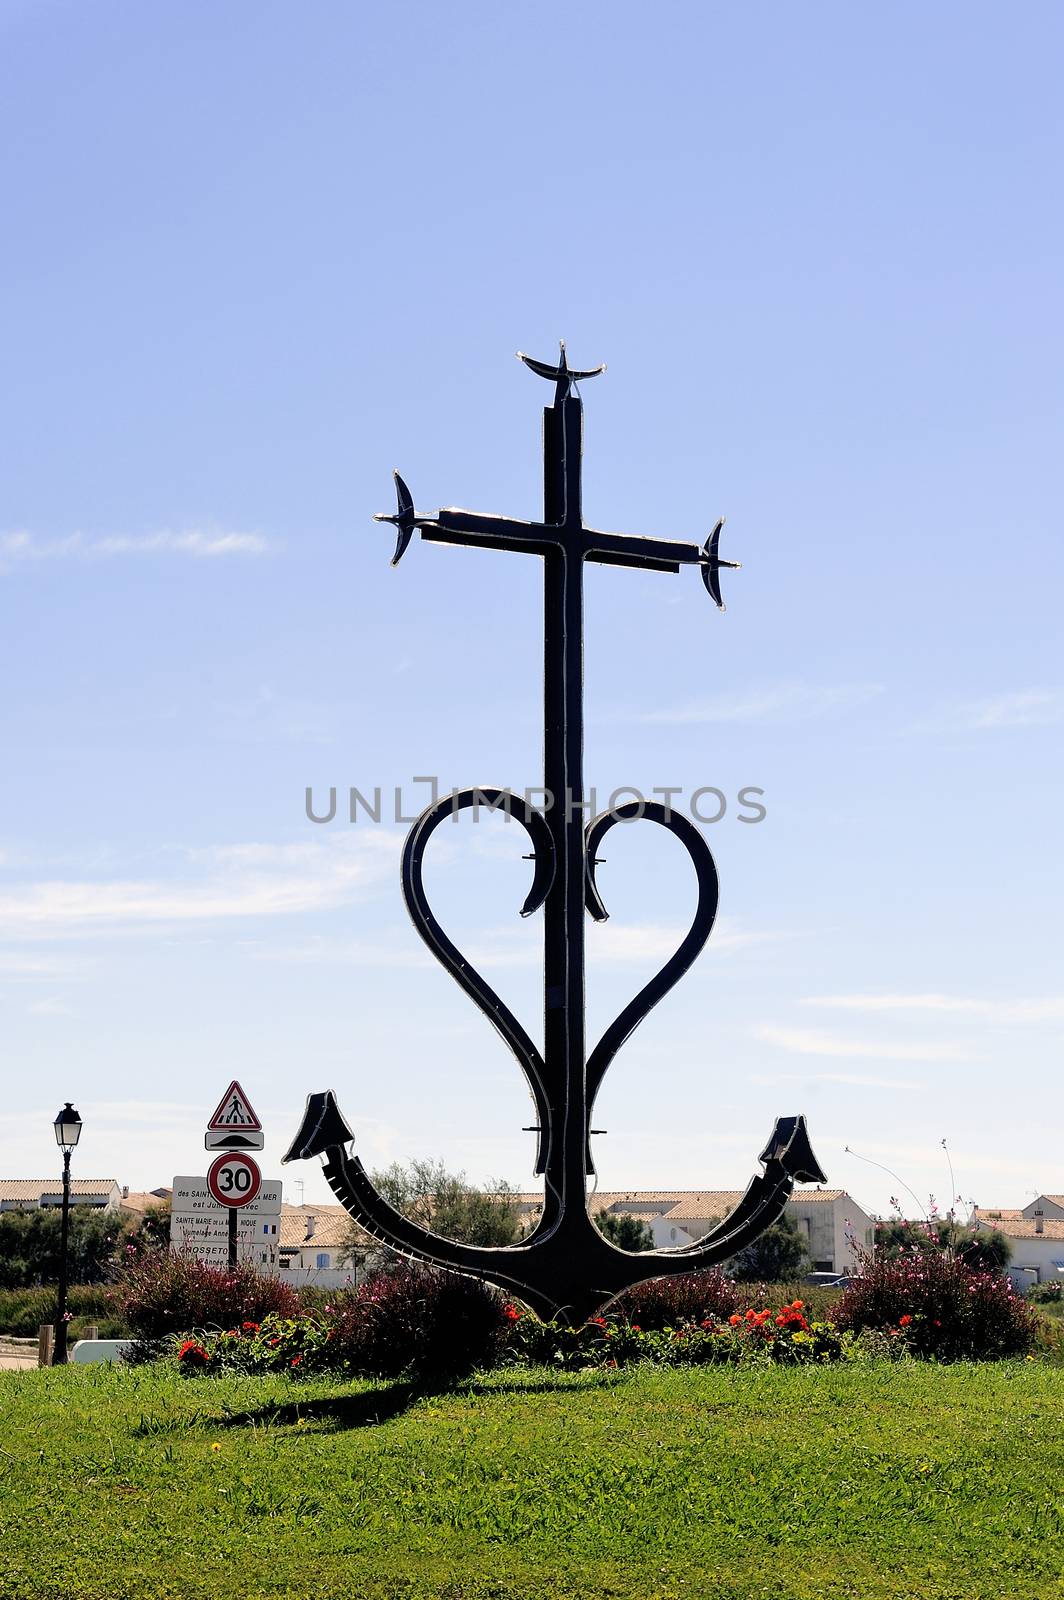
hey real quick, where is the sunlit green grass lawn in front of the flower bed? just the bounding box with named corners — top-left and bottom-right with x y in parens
top-left (0, 1362), bottom-right (1064, 1600)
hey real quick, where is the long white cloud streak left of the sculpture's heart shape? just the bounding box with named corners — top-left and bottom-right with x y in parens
top-left (0, 829), bottom-right (398, 938)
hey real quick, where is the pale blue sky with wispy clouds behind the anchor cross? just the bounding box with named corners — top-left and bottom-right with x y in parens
top-left (0, 0), bottom-right (1064, 1208)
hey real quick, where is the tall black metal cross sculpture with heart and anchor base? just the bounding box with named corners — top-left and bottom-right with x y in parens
top-left (285, 344), bottom-right (824, 1323)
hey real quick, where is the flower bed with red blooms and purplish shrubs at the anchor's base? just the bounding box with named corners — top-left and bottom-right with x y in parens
top-left (122, 1251), bottom-right (1045, 1381)
